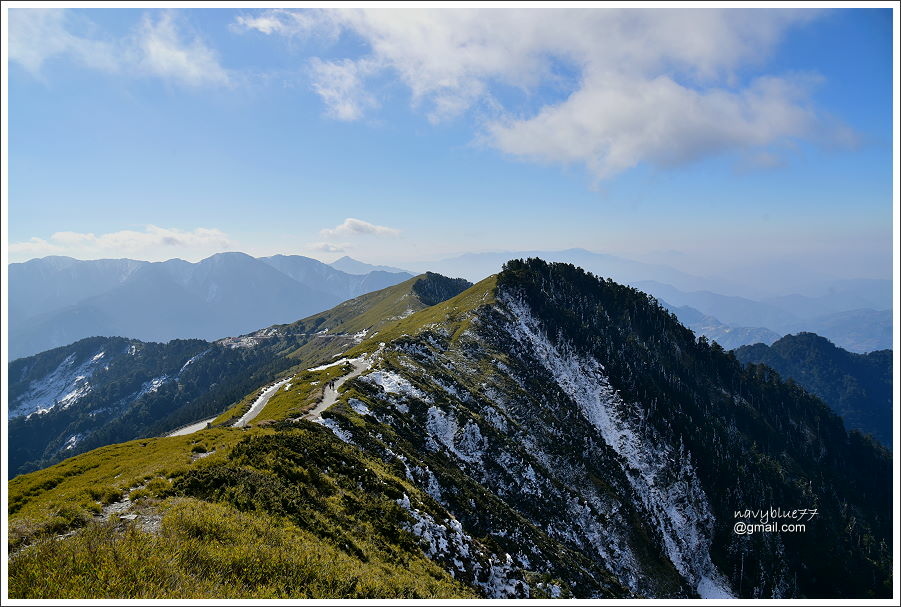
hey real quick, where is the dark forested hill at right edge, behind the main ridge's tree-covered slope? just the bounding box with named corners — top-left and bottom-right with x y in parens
top-left (734, 333), bottom-right (892, 447)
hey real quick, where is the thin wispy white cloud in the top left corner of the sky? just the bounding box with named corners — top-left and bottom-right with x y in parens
top-left (9, 9), bottom-right (230, 86)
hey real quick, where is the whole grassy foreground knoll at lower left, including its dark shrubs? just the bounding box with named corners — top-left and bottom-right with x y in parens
top-left (9, 424), bottom-right (473, 598)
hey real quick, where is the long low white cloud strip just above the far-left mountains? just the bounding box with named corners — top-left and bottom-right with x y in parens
top-left (9, 225), bottom-right (232, 260)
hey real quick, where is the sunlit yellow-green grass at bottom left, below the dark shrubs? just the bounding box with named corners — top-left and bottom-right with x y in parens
top-left (9, 498), bottom-right (469, 599)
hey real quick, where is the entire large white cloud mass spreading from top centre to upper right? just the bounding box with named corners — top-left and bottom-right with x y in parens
top-left (236, 8), bottom-right (848, 178)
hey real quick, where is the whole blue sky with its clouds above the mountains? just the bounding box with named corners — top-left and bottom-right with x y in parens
top-left (8, 9), bottom-right (893, 278)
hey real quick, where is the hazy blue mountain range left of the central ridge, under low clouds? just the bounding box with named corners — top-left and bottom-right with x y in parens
top-left (9, 253), bottom-right (412, 359)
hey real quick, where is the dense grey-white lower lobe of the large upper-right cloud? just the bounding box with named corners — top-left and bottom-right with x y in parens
top-left (488, 76), bottom-right (817, 178)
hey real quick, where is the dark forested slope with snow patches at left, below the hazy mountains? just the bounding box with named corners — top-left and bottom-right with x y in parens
top-left (8, 337), bottom-right (278, 475)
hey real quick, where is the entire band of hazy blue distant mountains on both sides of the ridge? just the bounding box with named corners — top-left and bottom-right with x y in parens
top-left (9, 249), bottom-right (892, 358)
